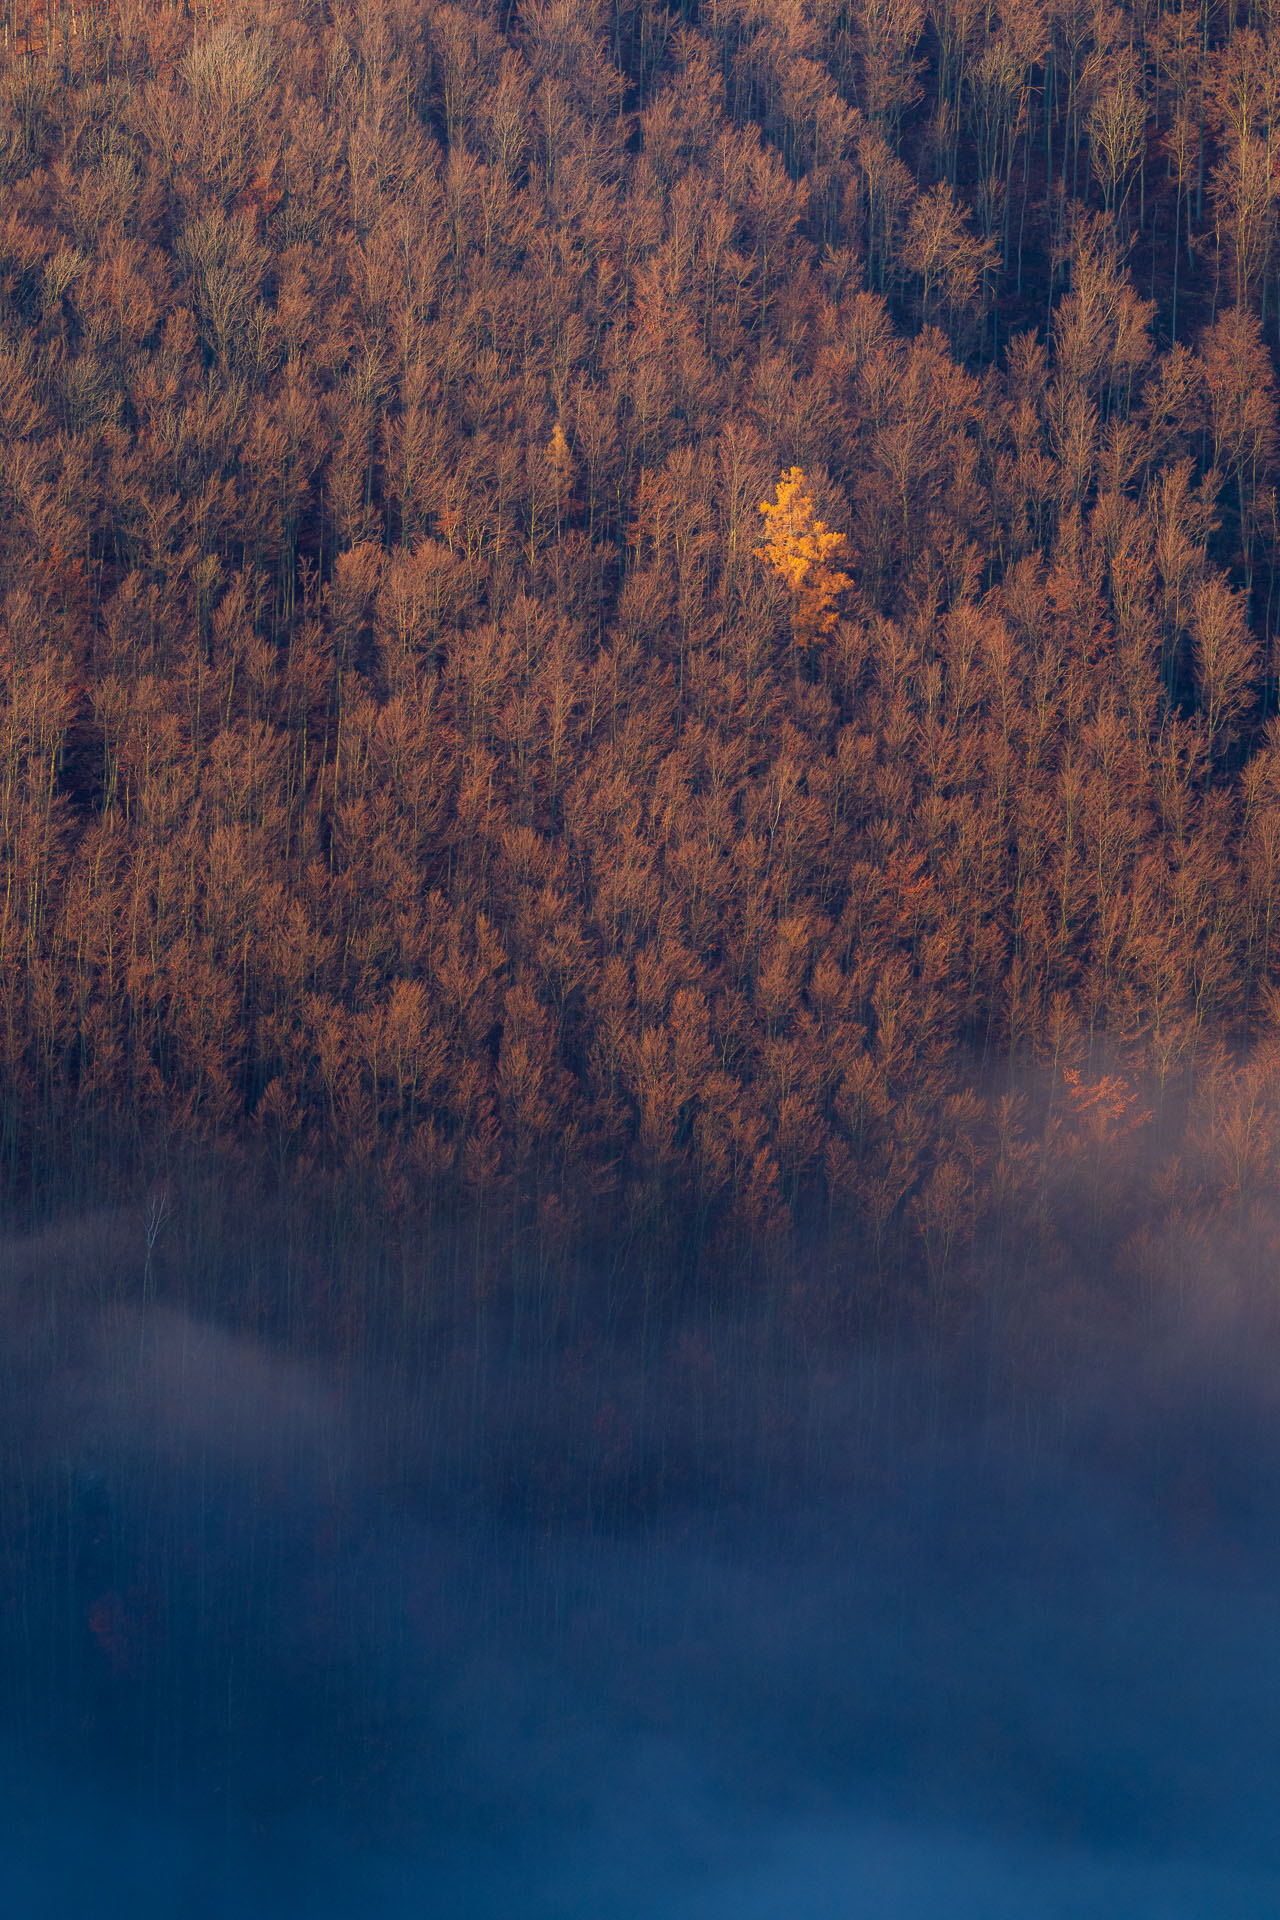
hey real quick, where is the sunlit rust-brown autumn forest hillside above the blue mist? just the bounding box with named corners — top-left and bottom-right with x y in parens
top-left (0, 0), bottom-right (1280, 1288)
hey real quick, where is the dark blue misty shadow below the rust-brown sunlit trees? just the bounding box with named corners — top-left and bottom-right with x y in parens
top-left (0, 1251), bottom-right (1280, 1920)
